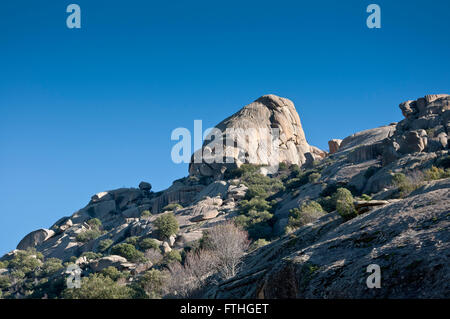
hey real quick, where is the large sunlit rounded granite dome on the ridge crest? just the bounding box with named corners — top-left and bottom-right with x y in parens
top-left (189, 95), bottom-right (326, 178)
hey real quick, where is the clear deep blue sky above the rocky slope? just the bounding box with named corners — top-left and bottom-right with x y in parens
top-left (0, 0), bottom-right (450, 254)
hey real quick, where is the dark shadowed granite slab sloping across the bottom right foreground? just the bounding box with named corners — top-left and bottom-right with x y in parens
top-left (205, 185), bottom-right (450, 299)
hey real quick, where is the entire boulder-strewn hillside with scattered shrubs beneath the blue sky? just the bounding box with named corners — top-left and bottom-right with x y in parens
top-left (0, 95), bottom-right (450, 298)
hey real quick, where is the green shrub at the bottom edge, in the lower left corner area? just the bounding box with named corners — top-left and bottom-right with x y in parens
top-left (63, 274), bottom-right (133, 299)
